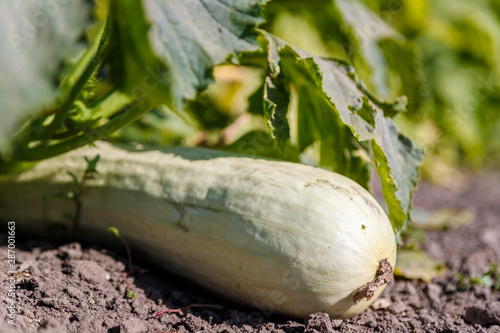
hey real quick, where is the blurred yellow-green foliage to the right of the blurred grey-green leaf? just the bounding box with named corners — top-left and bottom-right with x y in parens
top-left (365, 0), bottom-right (500, 174)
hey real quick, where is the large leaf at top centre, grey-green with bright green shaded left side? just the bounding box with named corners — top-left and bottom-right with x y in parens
top-left (110, 0), bottom-right (265, 109)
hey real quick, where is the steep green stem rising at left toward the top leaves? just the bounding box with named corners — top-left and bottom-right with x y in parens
top-left (38, 22), bottom-right (109, 141)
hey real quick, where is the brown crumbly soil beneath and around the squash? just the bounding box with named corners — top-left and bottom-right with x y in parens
top-left (0, 171), bottom-right (500, 333)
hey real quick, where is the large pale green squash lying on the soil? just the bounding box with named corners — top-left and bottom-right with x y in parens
top-left (0, 143), bottom-right (396, 318)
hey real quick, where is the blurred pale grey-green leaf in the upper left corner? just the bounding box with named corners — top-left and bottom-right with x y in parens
top-left (0, 0), bottom-right (91, 149)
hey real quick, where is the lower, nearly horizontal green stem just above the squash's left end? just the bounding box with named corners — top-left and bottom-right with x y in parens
top-left (13, 102), bottom-right (156, 161)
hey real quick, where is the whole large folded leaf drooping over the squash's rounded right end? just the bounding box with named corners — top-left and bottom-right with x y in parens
top-left (256, 35), bottom-right (423, 232)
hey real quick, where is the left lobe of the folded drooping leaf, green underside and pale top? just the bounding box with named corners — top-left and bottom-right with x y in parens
top-left (274, 42), bottom-right (373, 188)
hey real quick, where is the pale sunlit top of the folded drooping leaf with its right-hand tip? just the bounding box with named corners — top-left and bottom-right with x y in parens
top-left (304, 57), bottom-right (423, 226)
